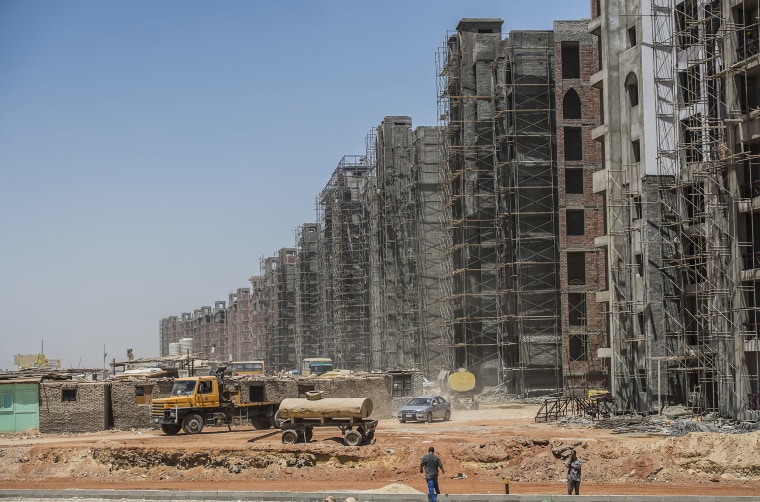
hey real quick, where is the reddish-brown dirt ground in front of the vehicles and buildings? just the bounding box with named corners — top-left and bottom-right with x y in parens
top-left (0, 403), bottom-right (760, 496)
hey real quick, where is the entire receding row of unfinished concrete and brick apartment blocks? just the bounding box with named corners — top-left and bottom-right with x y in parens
top-left (156, 5), bottom-right (760, 419)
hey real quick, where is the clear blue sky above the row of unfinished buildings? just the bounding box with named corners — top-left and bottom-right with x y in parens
top-left (0, 0), bottom-right (590, 370)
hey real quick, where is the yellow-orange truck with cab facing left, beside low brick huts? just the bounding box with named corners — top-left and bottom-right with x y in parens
top-left (151, 368), bottom-right (279, 436)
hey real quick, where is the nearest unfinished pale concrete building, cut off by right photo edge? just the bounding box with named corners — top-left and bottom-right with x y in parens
top-left (589, 0), bottom-right (760, 418)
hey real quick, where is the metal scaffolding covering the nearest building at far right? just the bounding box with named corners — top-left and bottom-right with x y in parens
top-left (640, 0), bottom-right (760, 418)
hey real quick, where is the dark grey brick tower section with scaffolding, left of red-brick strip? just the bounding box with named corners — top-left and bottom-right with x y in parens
top-left (439, 19), bottom-right (563, 394)
